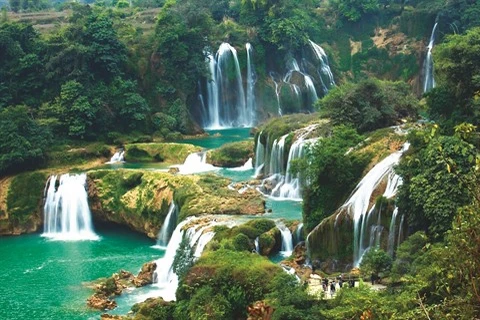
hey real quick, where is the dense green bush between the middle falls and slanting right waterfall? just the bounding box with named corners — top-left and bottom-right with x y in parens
top-left (299, 126), bottom-right (370, 230)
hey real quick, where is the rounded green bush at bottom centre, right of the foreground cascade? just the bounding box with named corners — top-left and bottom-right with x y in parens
top-left (177, 248), bottom-right (282, 319)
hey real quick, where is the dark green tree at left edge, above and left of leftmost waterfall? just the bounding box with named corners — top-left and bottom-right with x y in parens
top-left (0, 106), bottom-right (51, 175)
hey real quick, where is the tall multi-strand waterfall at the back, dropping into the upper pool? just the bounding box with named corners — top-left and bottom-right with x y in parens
top-left (204, 42), bottom-right (255, 129)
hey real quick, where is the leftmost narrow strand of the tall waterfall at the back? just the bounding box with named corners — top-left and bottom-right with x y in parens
top-left (206, 54), bottom-right (221, 129)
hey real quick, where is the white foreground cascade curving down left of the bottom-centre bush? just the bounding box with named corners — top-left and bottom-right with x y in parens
top-left (153, 216), bottom-right (238, 301)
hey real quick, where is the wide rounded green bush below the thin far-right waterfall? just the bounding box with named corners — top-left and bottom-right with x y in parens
top-left (317, 79), bottom-right (417, 132)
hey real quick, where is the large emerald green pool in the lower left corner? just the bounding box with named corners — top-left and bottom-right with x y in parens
top-left (0, 230), bottom-right (163, 320)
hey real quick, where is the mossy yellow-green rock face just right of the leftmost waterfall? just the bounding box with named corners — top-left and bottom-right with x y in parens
top-left (88, 170), bottom-right (265, 239)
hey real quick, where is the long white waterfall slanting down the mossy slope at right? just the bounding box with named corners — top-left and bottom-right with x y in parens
top-left (342, 143), bottom-right (409, 266)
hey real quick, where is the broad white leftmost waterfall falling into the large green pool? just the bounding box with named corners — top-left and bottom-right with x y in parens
top-left (42, 173), bottom-right (98, 240)
